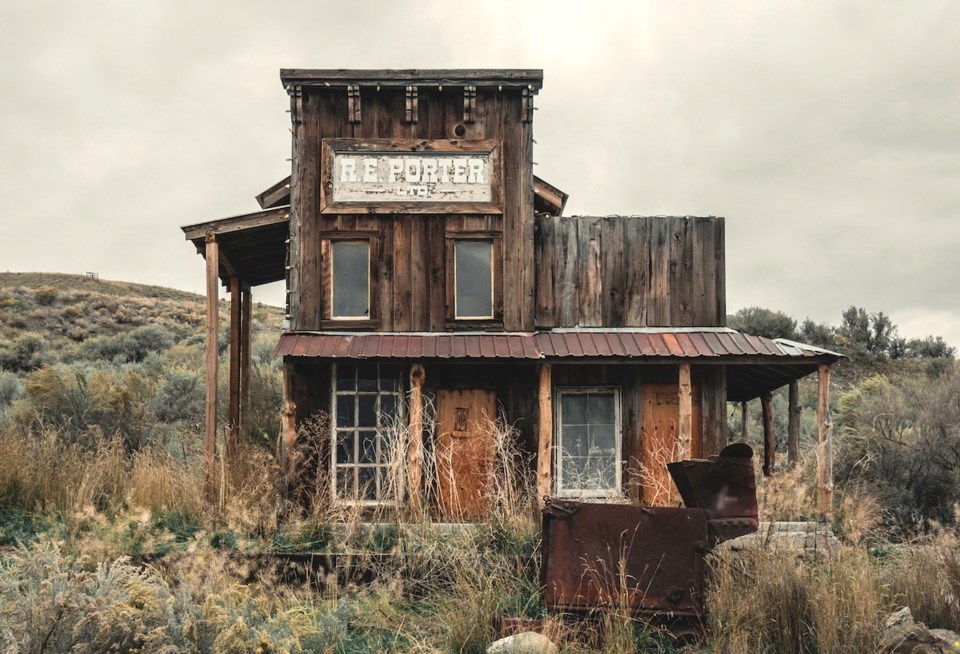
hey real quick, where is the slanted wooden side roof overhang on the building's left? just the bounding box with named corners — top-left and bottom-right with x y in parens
top-left (181, 206), bottom-right (290, 286)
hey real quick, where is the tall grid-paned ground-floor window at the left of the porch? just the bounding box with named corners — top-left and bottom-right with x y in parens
top-left (333, 364), bottom-right (403, 502)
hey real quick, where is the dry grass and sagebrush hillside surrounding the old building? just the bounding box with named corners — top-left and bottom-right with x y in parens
top-left (0, 273), bottom-right (960, 654)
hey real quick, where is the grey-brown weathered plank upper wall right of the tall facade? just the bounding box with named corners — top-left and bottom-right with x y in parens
top-left (535, 215), bottom-right (726, 327)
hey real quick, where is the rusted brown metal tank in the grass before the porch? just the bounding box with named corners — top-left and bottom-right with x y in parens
top-left (540, 443), bottom-right (758, 617)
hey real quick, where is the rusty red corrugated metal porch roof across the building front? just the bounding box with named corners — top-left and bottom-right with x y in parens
top-left (276, 328), bottom-right (842, 361)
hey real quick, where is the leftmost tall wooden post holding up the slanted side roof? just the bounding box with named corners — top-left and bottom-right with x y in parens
top-left (203, 233), bottom-right (220, 504)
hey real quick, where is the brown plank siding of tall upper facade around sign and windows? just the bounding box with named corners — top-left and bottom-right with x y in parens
top-left (288, 86), bottom-right (534, 331)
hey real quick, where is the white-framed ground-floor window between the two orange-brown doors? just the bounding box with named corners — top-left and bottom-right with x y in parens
top-left (556, 388), bottom-right (621, 497)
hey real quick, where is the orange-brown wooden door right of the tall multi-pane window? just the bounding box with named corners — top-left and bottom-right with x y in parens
top-left (436, 390), bottom-right (497, 520)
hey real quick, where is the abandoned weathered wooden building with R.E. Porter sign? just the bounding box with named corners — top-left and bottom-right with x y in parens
top-left (183, 69), bottom-right (838, 520)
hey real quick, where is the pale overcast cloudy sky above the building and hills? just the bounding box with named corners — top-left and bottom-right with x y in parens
top-left (0, 0), bottom-right (960, 346)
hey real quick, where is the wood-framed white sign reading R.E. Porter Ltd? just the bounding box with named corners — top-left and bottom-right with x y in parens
top-left (320, 139), bottom-right (503, 214)
